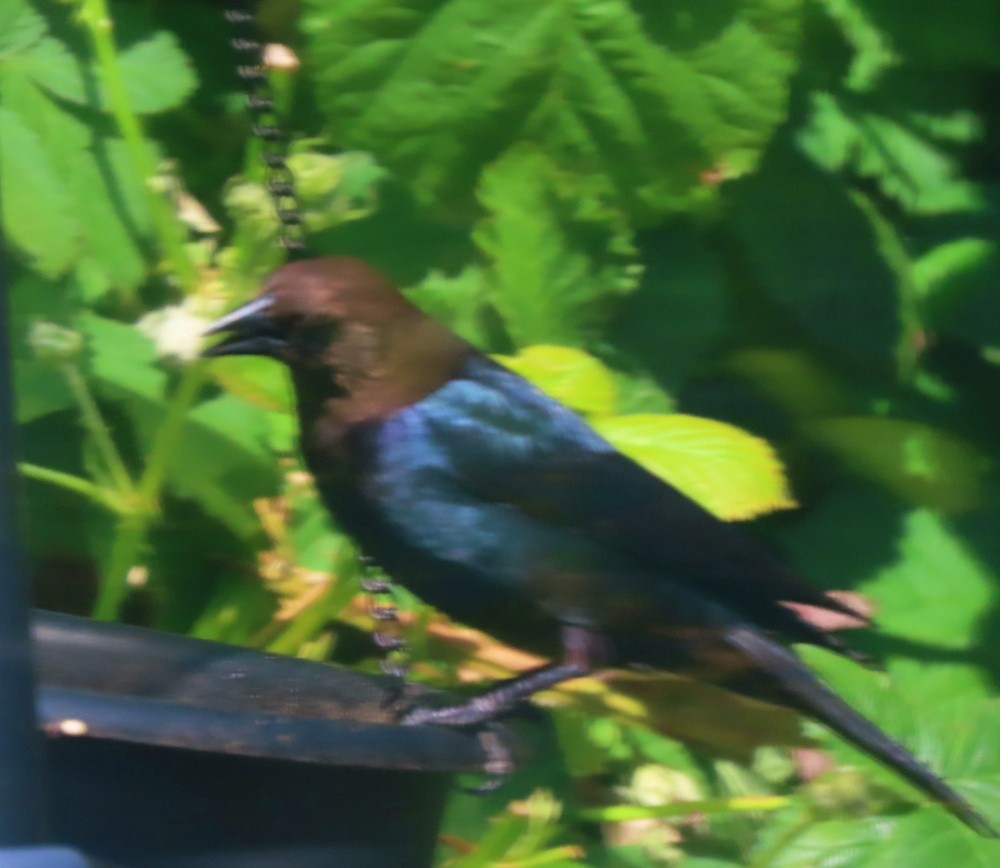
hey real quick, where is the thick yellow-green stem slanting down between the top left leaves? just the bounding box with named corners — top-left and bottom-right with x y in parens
top-left (79, 0), bottom-right (198, 292)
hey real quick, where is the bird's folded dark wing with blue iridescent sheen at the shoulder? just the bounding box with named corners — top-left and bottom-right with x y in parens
top-left (421, 357), bottom-right (858, 645)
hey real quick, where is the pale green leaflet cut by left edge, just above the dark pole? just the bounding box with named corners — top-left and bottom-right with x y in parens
top-left (0, 108), bottom-right (77, 277)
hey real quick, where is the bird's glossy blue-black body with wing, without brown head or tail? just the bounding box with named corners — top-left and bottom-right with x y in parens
top-left (306, 356), bottom-right (856, 660)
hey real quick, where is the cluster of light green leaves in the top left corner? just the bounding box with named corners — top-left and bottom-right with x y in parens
top-left (0, 0), bottom-right (196, 298)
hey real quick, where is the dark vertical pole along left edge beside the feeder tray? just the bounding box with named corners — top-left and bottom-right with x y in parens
top-left (0, 248), bottom-right (44, 847)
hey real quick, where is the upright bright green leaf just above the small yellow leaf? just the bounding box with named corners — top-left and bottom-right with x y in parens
top-left (473, 148), bottom-right (639, 346)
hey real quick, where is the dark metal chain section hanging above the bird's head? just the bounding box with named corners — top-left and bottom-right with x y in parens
top-left (225, 2), bottom-right (306, 256)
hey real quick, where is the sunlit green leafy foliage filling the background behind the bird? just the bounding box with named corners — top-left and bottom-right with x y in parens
top-left (0, 0), bottom-right (1000, 868)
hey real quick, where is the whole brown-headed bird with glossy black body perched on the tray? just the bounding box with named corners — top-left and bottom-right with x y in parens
top-left (203, 256), bottom-right (997, 837)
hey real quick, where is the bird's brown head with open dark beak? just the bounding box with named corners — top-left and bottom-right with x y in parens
top-left (202, 257), bottom-right (473, 421)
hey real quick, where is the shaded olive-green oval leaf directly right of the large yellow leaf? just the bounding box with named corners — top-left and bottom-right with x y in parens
top-left (804, 416), bottom-right (990, 511)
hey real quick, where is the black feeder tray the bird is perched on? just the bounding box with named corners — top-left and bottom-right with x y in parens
top-left (33, 612), bottom-right (504, 868)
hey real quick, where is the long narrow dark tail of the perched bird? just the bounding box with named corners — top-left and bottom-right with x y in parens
top-left (726, 627), bottom-right (1000, 838)
